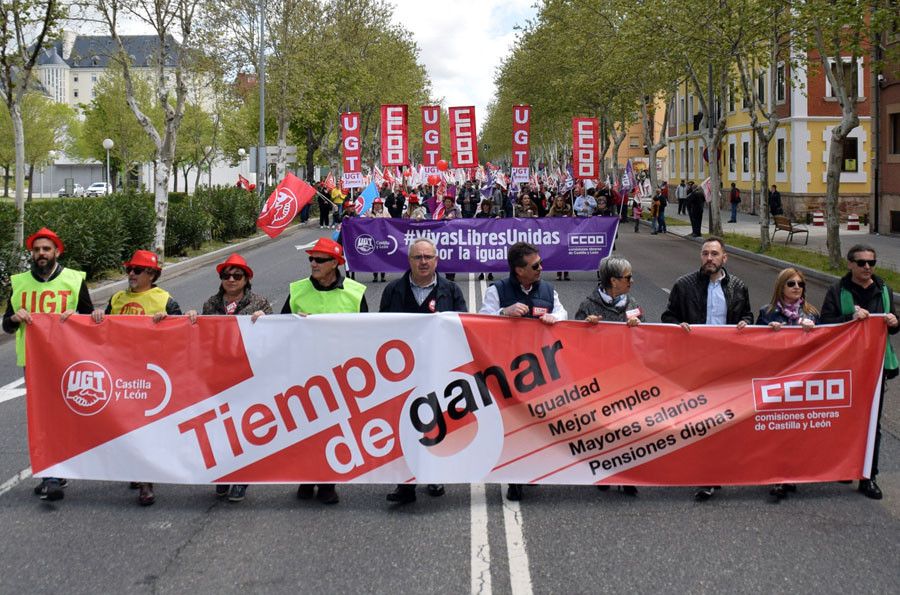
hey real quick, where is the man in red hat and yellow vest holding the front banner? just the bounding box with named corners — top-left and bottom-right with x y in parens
top-left (92, 250), bottom-right (181, 506)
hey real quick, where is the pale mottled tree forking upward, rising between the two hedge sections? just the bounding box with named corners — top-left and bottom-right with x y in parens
top-left (97, 0), bottom-right (201, 259)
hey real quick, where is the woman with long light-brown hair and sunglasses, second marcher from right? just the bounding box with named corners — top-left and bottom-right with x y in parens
top-left (756, 267), bottom-right (819, 502)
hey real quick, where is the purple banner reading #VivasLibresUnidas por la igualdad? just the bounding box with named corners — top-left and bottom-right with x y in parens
top-left (341, 217), bottom-right (619, 273)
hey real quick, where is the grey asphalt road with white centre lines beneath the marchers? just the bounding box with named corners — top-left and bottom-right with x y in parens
top-left (0, 227), bottom-right (900, 594)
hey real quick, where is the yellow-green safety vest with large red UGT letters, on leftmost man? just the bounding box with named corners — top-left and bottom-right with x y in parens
top-left (9, 268), bottom-right (85, 366)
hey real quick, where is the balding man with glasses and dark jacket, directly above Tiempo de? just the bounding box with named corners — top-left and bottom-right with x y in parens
top-left (378, 238), bottom-right (468, 504)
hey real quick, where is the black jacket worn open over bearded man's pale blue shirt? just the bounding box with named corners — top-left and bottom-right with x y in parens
top-left (662, 271), bottom-right (753, 324)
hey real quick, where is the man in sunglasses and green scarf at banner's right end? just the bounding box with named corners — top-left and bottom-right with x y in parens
top-left (819, 244), bottom-right (900, 500)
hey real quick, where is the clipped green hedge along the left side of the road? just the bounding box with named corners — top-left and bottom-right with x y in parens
top-left (0, 187), bottom-right (259, 301)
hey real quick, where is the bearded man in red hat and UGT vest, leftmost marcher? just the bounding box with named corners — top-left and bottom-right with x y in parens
top-left (3, 227), bottom-right (94, 500)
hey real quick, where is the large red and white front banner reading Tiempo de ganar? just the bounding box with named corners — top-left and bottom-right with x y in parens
top-left (26, 313), bottom-right (886, 485)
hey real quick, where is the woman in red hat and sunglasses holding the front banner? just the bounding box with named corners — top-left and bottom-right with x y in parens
top-left (188, 254), bottom-right (272, 502)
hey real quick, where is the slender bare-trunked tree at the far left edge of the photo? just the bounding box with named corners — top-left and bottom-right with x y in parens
top-left (0, 0), bottom-right (65, 246)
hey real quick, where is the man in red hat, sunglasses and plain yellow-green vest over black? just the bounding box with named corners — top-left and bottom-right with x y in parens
top-left (281, 238), bottom-right (369, 504)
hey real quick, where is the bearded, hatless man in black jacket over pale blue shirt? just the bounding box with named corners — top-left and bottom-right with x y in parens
top-left (662, 236), bottom-right (753, 502)
